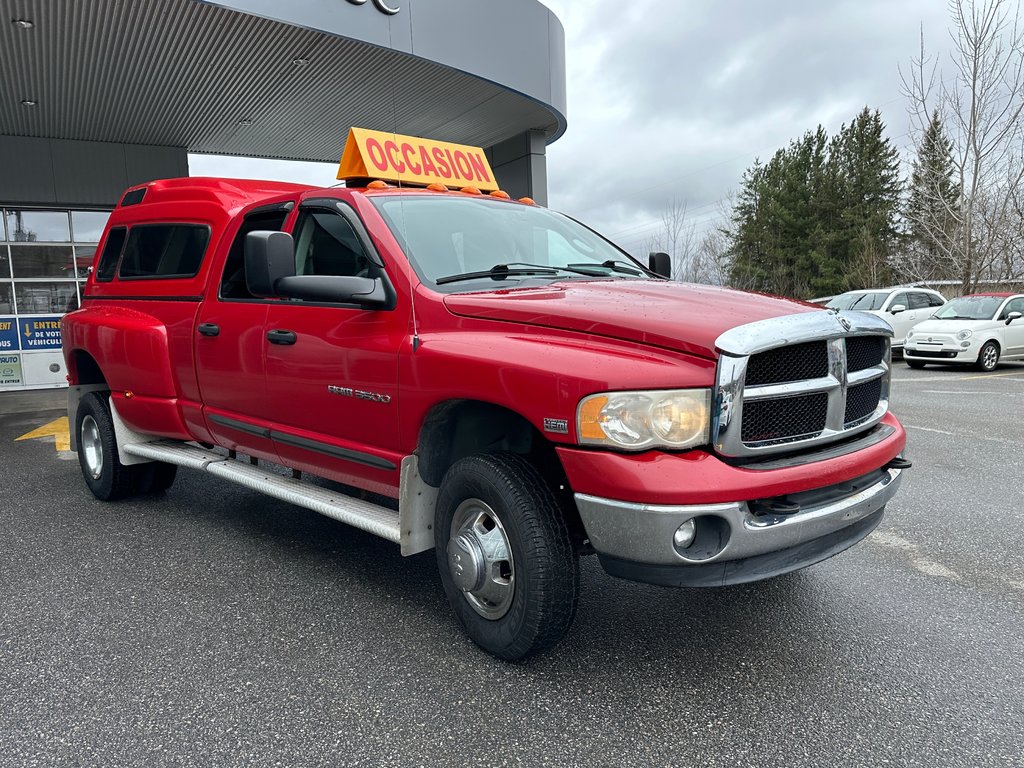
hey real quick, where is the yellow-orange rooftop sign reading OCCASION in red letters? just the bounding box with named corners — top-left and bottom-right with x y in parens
top-left (338, 128), bottom-right (498, 191)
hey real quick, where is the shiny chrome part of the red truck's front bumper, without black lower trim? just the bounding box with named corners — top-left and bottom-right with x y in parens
top-left (575, 469), bottom-right (901, 581)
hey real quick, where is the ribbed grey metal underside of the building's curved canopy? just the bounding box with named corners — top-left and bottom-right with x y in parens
top-left (0, 0), bottom-right (564, 161)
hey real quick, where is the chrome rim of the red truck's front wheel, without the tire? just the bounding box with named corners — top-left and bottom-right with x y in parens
top-left (447, 499), bottom-right (515, 621)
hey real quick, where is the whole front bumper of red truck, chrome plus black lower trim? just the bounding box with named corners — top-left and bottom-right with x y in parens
top-left (575, 468), bottom-right (901, 587)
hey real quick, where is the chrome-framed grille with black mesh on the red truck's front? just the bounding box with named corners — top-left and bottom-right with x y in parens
top-left (713, 312), bottom-right (891, 457)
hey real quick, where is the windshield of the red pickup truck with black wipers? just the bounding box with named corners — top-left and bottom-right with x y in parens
top-left (371, 196), bottom-right (647, 290)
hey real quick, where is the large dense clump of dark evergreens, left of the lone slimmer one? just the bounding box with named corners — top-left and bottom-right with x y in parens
top-left (730, 108), bottom-right (900, 298)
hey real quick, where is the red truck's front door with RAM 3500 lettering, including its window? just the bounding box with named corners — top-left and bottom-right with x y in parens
top-left (262, 201), bottom-right (409, 494)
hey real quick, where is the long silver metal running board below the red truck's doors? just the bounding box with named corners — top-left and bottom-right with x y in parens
top-left (121, 440), bottom-right (403, 555)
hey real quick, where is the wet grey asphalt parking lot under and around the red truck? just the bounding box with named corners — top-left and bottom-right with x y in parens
top-left (0, 362), bottom-right (1024, 768)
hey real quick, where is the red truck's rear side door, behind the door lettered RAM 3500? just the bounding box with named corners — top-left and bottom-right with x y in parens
top-left (193, 202), bottom-right (295, 461)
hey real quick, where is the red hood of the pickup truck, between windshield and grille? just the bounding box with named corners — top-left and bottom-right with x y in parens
top-left (444, 280), bottom-right (825, 359)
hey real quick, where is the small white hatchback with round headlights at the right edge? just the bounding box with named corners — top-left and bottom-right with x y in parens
top-left (903, 293), bottom-right (1024, 371)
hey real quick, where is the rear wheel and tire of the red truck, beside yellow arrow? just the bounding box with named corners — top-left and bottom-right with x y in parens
top-left (75, 392), bottom-right (146, 502)
